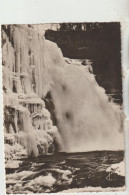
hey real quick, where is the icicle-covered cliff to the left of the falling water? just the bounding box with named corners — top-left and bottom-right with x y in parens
top-left (2, 25), bottom-right (61, 159)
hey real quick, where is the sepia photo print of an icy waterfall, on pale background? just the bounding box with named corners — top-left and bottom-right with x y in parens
top-left (1, 22), bottom-right (126, 194)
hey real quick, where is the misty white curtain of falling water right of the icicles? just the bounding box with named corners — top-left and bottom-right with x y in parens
top-left (44, 40), bottom-right (124, 152)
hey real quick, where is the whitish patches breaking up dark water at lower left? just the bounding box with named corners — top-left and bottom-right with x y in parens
top-left (6, 168), bottom-right (72, 193)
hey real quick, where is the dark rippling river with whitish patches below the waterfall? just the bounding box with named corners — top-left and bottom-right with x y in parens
top-left (6, 151), bottom-right (125, 193)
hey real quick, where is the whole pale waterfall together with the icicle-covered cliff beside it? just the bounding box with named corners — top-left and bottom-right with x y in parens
top-left (2, 25), bottom-right (124, 162)
